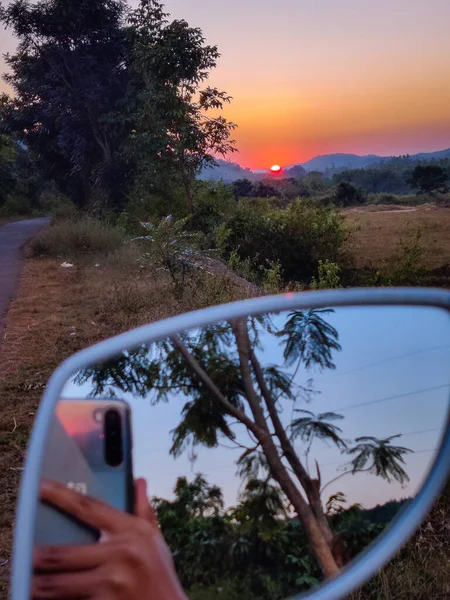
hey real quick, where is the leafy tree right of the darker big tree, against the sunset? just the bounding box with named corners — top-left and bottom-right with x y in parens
top-left (125, 0), bottom-right (236, 211)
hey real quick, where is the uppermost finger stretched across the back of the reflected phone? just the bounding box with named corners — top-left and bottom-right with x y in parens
top-left (40, 481), bottom-right (131, 533)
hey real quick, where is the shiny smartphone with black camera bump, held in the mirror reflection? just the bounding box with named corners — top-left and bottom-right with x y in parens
top-left (34, 399), bottom-right (134, 546)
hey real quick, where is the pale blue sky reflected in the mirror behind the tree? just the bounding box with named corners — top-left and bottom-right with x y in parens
top-left (59, 307), bottom-right (450, 508)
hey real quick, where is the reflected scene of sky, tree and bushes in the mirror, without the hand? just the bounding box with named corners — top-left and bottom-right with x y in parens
top-left (39, 307), bottom-right (450, 599)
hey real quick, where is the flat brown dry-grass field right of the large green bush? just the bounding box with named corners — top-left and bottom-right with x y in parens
top-left (345, 205), bottom-right (450, 269)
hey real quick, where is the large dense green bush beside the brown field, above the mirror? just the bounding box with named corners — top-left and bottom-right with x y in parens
top-left (217, 200), bottom-right (347, 282)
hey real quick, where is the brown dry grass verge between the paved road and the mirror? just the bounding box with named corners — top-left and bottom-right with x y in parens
top-left (0, 247), bottom-right (259, 598)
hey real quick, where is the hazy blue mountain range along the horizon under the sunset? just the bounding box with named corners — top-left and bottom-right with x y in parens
top-left (200, 148), bottom-right (450, 183)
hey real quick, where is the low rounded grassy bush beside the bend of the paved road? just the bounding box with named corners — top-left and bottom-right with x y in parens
top-left (31, 217), bottom-right (126, 261)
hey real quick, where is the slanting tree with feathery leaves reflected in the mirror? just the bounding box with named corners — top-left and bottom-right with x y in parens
top-left (77, 309), bottom-right (408, 577)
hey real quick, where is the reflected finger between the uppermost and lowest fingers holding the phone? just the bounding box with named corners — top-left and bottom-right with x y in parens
top-left (33, 544), bottom-right (112, 573)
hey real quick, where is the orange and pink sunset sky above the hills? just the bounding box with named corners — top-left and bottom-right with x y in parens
top-left (0, 0), bottom-right (450, 169)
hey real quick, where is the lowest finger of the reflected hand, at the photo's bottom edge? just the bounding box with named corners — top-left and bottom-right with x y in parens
top-left (31, 569), bottom-right (101, 600)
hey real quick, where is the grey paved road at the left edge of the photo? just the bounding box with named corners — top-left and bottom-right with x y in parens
top-left (0, 218), bottom-right (50, 342)
